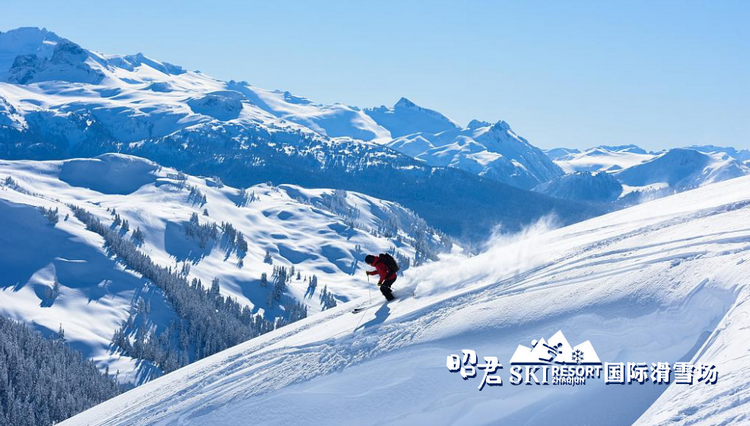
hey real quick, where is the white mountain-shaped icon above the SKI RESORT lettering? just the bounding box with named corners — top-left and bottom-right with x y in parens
top-left (510, 331), bottom-right (602, 365)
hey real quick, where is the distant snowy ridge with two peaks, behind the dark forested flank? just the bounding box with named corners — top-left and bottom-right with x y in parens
top-left (237, 92), bottom-right (561, 189)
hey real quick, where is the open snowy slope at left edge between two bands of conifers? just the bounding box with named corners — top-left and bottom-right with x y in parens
top-left (0, 188), bottom-right (160, 383)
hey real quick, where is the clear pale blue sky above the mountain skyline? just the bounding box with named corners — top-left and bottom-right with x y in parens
top-left (0, 0), bottom-right (750, 149)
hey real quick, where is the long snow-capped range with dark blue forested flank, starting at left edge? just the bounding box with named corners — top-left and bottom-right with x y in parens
top-left (0, 28), bottom-right (600, 242)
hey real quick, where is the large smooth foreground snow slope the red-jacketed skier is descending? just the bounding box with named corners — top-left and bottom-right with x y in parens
top-left (64, 171), bottom-right (750, 425)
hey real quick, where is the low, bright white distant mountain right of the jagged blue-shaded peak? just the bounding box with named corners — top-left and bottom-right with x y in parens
top-left (546, 145), bottom-right (655, 173)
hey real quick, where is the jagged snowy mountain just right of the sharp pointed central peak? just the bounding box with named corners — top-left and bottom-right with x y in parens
top-left (386, 116), bottom-right (563, 189)
